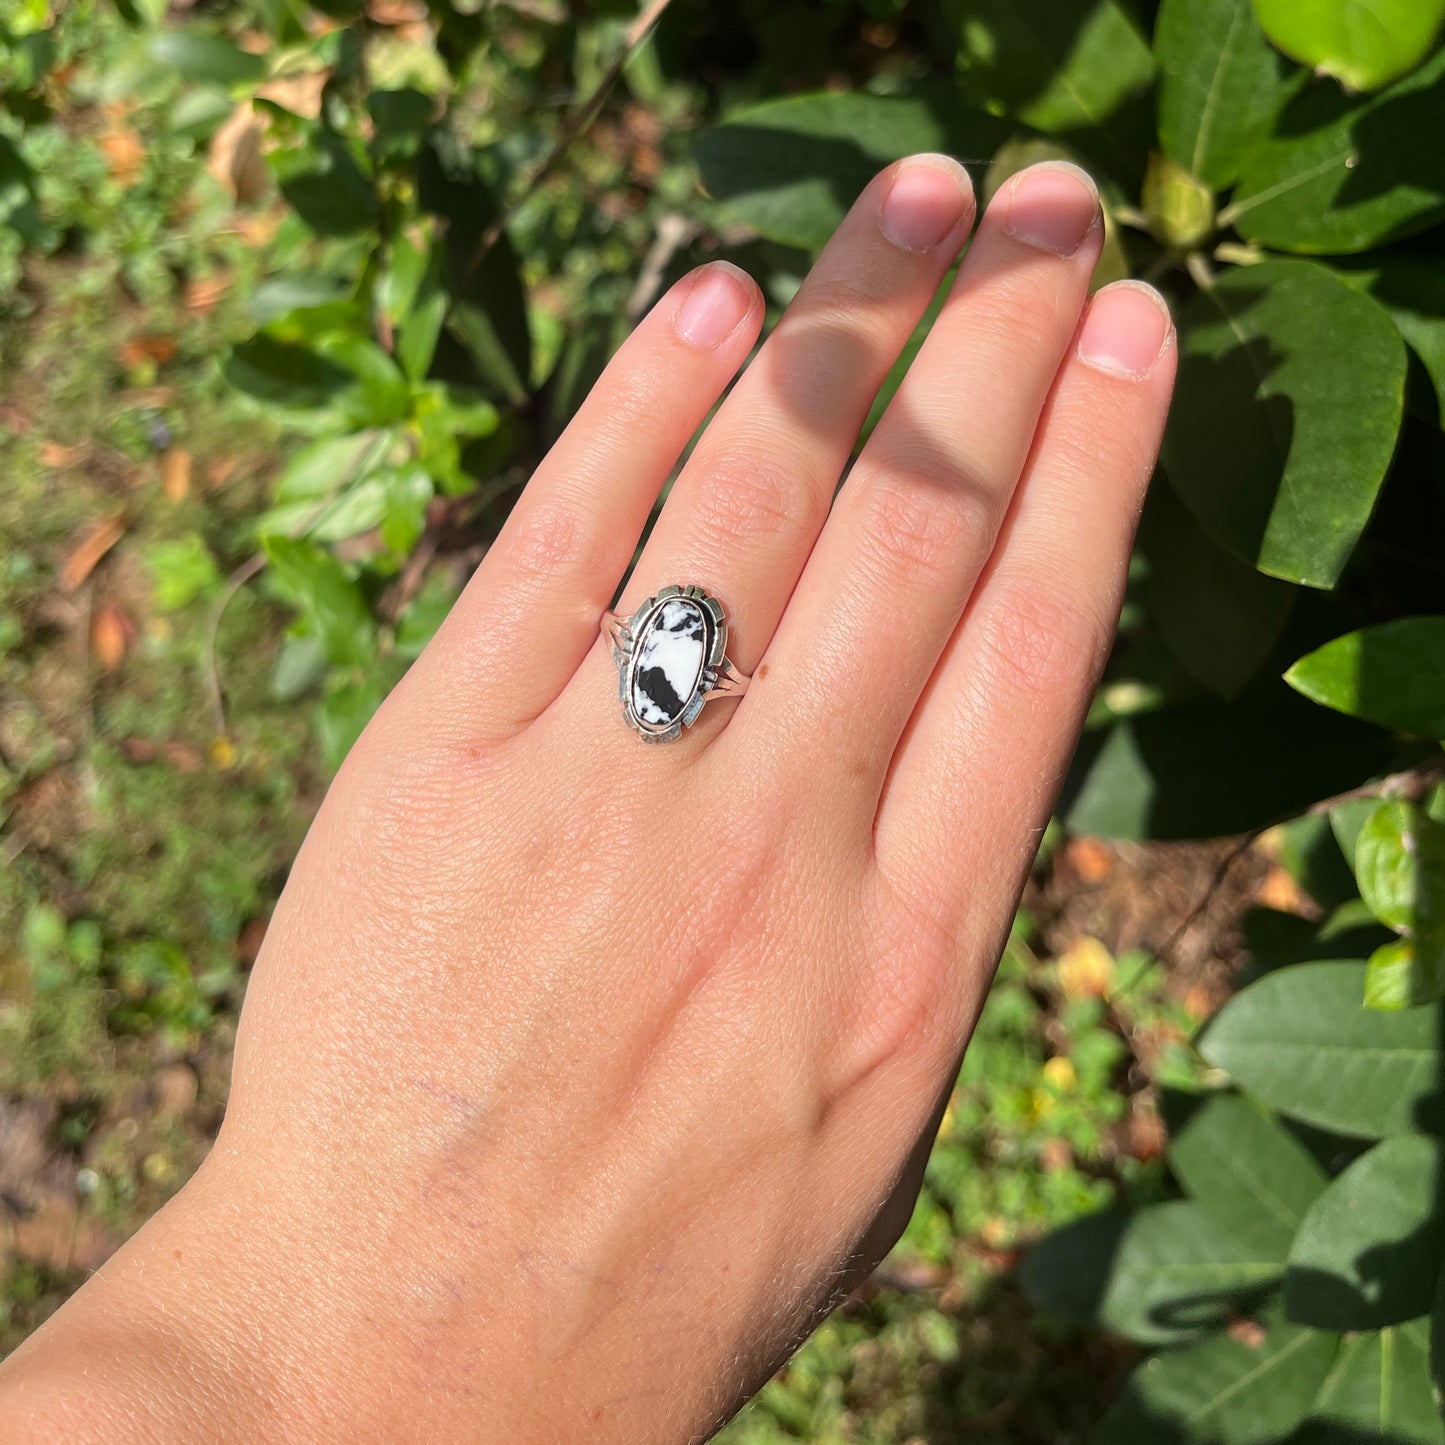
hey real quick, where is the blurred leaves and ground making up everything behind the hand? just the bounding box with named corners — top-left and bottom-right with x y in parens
top-left (8, 0), bottom-right (1445, 1445)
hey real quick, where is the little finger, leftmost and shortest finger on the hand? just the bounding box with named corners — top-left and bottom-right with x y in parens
top-left (413, 262), bottom-right (763, 736)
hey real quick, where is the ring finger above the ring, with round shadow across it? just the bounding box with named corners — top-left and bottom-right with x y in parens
top-left (592, 156), bottom-right (972, 693)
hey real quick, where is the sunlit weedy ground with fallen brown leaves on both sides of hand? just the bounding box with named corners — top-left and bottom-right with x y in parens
top-left (0, 8), bottom-right (1219, 1445)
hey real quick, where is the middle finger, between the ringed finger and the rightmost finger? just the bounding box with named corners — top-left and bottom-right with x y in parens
top-left (759, 162), bottom-right (1103, 780)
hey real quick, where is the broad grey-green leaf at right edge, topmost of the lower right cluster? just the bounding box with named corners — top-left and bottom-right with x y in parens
top-left (1199, 962), bottom-right (1445, 1139)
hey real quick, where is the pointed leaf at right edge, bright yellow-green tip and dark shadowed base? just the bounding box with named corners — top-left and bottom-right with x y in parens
top-left (1285, 617), bottom-right (1445, 737)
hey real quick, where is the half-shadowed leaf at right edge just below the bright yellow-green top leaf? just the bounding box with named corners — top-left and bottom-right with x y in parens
top-left (1220, 51), bottom-right (1445, 254)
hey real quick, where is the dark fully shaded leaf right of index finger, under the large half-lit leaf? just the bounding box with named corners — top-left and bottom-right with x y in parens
top-left (1139, 487), bottom-right (1295, 698)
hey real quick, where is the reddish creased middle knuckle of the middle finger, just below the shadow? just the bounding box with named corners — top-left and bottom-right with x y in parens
top-left (863, 458), bottom-right (994, 578)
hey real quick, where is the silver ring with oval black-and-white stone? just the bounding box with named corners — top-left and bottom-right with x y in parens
top-left (603, 587), bottom-right (751, 743)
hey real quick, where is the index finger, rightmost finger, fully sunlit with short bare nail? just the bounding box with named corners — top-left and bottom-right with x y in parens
top-left (874, 282), bottom-right (1176, 926)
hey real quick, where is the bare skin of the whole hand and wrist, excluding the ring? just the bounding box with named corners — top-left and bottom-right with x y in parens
top-left (0, 156), bottom-right (1175, 1445)
